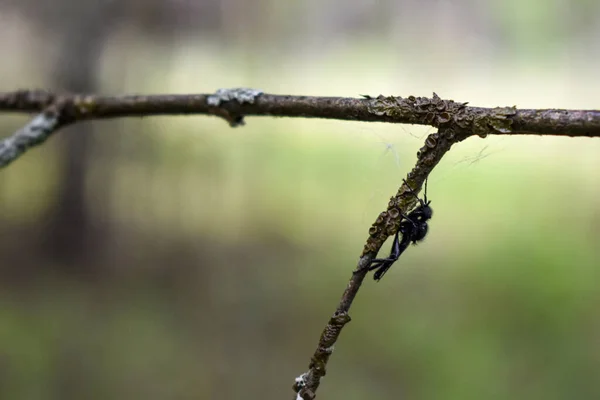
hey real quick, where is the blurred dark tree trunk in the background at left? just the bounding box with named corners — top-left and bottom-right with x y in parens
top-left (40, 0), bottom-right (114, 275)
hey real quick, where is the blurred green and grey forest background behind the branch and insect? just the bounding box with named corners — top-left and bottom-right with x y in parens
top-left (0, 0), bottom-right (600, 400)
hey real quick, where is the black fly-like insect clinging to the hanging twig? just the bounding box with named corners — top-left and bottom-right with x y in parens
top-left (369, 180), bottom-right (433, 281)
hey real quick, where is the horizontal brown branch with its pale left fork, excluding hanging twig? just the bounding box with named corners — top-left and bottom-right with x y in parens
top-left (0, 88), bottom-right (600, 167)
